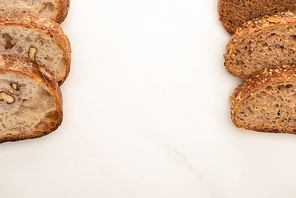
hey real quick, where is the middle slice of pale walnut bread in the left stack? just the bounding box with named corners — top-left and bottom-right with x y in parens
top-left (0, 13), bottom-right (71, 85)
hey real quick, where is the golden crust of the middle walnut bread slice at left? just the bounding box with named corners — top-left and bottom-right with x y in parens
top-left (0, 13), bottom-right (71, 85)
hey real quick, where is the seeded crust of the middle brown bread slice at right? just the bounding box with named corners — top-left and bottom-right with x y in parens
top-left (224, 11), bottom-right (296, 78)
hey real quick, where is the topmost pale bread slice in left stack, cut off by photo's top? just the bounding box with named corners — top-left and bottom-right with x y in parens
top-left (0, 0), bottom-right (70, 23)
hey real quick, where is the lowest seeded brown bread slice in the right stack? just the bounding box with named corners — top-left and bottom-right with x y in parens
top-left (230, 65), bottom-right (296, 134)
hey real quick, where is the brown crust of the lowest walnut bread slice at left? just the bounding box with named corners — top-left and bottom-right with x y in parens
top-left (0, 55), bottom-right (63, 143)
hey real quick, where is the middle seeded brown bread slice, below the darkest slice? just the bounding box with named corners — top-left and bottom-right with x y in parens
top-left (224, 11), bottom-right (296, 78)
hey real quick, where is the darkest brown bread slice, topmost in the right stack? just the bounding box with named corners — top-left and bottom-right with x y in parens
top-left (218, 0), bottom-right (296, 35)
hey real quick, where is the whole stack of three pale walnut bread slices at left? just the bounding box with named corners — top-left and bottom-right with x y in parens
top-left (0, 0), bottom-right (71, 143)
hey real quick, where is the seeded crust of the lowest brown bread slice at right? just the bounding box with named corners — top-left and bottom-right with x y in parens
top-left (229, 65), bottom-right (296, 133)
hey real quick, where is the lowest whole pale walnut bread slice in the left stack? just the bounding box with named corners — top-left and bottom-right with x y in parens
top-left (0, 55), bottom-right (63, 143)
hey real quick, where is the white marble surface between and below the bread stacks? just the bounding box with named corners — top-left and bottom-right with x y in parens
top-left (0, 0), bottom-right (296, 198)
